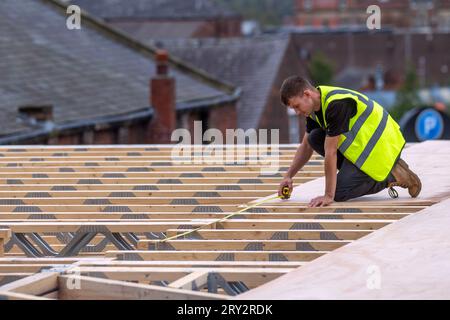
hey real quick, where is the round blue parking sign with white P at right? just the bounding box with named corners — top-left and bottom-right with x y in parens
top-left (415, 108), bottom-right (444, 141)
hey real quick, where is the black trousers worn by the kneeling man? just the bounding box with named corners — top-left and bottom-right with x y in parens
top-left (308, 128), bottom-right (395, 201)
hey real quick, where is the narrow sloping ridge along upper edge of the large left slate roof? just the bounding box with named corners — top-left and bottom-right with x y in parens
top-left (40, 0), bottom-right (241, 98)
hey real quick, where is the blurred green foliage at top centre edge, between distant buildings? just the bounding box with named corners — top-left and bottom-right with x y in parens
top-left (215, 0), bottom-right (294, 27)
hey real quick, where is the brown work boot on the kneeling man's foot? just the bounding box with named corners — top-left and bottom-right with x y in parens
top-left (388, 159), bottom-right (422, 198)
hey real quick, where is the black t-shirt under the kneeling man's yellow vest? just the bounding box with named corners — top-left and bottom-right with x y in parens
top-left (306, 98), bottom-right (356, 137)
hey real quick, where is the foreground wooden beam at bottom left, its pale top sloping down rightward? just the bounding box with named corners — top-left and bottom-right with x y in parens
top-left (58, 275), bottom-right (227, 300)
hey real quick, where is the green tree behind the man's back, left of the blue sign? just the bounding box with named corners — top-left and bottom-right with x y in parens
top-left (389, 64), bottom-right (420, 121)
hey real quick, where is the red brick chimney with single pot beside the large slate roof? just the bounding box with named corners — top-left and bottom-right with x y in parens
top-left (149, 50), bottom-right (176, 143)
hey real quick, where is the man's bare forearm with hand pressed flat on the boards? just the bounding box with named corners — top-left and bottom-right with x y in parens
top-left (309, 136), bottom-right (339, 207)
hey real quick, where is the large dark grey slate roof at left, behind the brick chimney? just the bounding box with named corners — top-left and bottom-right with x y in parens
top-left (0, 0), bottom-right (239, 135)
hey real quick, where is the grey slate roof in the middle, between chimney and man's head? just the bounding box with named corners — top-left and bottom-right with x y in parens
top-left (153, 36), bottom-right (289, 129)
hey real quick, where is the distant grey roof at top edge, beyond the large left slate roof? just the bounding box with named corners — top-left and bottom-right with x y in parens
top-left (71, 0), bottom-right (238, 19)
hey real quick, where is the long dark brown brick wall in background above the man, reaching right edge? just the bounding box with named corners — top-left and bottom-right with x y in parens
top-left (292, 32), bottom-right (450, 85)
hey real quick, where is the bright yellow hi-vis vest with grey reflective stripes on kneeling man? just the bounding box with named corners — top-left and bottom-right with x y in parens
top-left (310, 86), bottom-right (405, 182)
